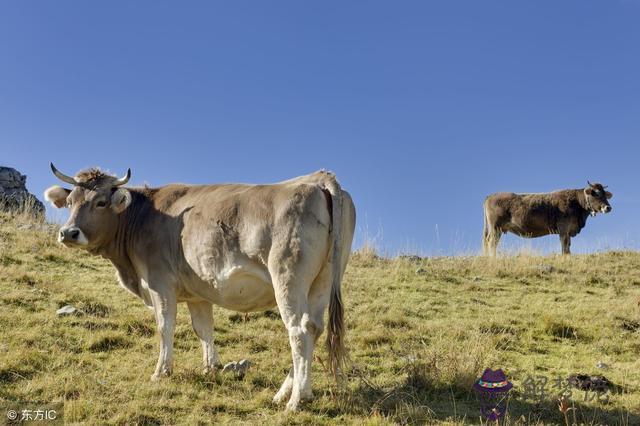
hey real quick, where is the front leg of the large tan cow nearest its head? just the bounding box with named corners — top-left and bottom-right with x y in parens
top-left (149, 285), bottom-right (178, 381)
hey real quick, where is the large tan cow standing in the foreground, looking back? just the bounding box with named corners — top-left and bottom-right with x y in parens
top-left (45, 164), bottom-right (355, 410)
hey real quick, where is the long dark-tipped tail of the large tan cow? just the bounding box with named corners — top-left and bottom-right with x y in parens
top-left (325, 172), bottom-right (346, 379)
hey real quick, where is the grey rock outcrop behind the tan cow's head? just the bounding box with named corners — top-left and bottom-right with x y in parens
top-left (0, 166), bottom-right (44, 216)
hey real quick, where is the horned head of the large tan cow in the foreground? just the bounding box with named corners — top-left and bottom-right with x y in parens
top-left (44, 163), bottom-right (131, 250)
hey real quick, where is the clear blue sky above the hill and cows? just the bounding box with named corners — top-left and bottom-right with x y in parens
top-left (0, 0), bottom-right (640, 254)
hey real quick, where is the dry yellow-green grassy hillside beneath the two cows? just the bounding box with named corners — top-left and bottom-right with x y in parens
top-left (0, 216), bottom-right (640, 424)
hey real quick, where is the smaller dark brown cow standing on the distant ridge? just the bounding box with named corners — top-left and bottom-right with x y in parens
top-left (483, 181), bottom-right (613, 256)
